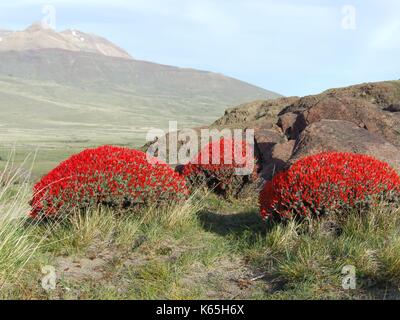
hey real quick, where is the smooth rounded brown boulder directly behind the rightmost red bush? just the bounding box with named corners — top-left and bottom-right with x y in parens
top-left (288, 119), bottom-right (400, 172)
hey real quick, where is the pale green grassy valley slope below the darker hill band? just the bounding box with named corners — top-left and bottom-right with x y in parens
top-left (0, 72), bottom-right (268, 177)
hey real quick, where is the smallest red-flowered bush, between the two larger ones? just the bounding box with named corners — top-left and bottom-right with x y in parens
top-left (182, 139), bottom-right (257, 198)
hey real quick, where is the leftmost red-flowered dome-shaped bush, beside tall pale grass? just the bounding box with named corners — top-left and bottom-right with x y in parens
top-left (31, 146), bottom-right (188, 217)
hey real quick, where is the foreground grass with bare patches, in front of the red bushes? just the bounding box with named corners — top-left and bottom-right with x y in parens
top-left (0, 165), bottom-right (400, 300)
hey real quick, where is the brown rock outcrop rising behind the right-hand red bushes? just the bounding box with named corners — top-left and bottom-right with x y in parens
top-left (143, 81), bottom-right (400, 195)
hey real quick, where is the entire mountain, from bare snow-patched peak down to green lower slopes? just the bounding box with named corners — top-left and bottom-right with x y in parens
top-left (0, 24), bottom-right (279, 143)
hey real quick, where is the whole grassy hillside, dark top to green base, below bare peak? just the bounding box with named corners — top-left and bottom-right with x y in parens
top-left (0, 50), bottom-right (277, 176)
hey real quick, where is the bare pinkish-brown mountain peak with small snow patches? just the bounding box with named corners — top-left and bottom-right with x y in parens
top-left (0, 22), bottom-right (132, 59)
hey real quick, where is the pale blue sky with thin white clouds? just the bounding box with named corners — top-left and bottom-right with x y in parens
top-left (0, 0), bottom-right (400, 96)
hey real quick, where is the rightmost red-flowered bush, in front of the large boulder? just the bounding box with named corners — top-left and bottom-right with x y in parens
top-left (260, 152), bottom-right (400, 219)
